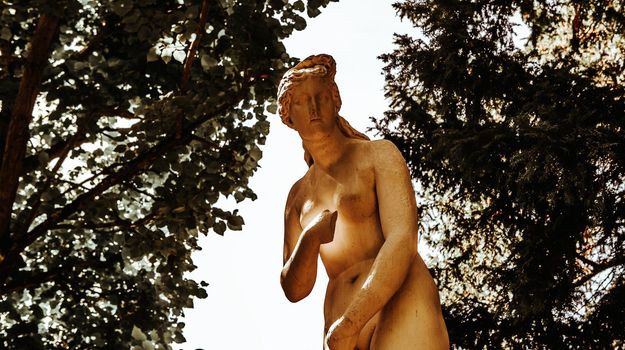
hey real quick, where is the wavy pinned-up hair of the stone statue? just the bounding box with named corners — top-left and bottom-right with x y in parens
top-left (278, 54), bottom-right (369, 166)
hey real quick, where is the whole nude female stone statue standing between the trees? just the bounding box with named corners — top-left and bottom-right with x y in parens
top-left (278, 55), bottom-right (449, 350)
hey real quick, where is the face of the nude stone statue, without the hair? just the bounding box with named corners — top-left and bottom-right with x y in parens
top-left (288, 77), bottom-right (336, 138)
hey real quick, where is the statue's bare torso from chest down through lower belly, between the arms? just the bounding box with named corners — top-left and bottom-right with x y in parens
top-left (298, 141), bottom-right (384, 349)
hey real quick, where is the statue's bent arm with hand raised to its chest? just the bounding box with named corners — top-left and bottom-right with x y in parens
top-left (280, 184), bottom-right (336, 302)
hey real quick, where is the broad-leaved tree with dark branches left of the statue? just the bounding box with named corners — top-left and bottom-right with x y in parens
top-left (0, 0), bottom-right (336, 349)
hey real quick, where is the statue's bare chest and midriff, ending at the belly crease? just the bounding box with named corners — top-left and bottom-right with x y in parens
top-left (298, 141), bottom-right (384, 280)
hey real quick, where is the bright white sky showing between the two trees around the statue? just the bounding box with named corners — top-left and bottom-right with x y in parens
top-left (179, 0), bottom-right (415, 350)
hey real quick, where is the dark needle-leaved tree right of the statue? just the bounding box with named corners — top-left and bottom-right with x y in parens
top-left (376, 0), bottom-right (625, 349)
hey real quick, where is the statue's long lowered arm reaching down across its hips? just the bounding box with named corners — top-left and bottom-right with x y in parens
top-left (337, 140), bottom-right (418, 335)
